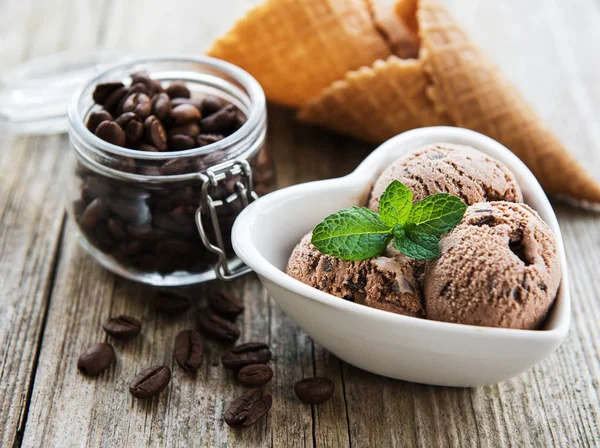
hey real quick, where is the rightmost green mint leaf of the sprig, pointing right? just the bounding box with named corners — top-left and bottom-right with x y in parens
top-left (408, 193), bottom-right (467, 236)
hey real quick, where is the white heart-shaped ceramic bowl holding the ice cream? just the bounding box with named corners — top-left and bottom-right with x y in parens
top-left (232, 127), bottom-right (571, 387)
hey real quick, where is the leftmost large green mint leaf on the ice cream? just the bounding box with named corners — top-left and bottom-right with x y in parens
top-left (311, 207), bottom-right (392, 261)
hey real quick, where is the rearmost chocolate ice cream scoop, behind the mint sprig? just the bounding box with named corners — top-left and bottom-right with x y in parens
top-left (369, 143), bottom-right (523, 211)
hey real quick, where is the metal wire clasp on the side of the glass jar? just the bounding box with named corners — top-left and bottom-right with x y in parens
top-left (196, 160), bottom-right (258, 280)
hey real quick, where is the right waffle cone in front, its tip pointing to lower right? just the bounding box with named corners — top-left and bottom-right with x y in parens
top-left (299, 0), bottom-right (600, 203)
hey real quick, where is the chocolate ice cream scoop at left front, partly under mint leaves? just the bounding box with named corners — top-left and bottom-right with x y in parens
top-left (286, 234), bottom-right (423, 317)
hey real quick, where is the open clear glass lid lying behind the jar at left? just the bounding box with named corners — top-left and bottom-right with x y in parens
top-left (0, 50), bottom-right (131, 135)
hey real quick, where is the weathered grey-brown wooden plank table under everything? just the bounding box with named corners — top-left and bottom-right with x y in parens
top-left (0, 0), bottom-right (600, 447)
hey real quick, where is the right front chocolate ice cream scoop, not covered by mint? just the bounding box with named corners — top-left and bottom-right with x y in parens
top-left (423, 202), bottom-right (561, 329)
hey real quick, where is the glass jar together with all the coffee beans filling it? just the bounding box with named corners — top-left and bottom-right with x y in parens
top-left (68, 58), bottom-right (274, 285)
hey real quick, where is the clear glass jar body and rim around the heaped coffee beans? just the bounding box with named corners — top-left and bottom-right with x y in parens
top-left (66, 57), bottom-right (274, 286)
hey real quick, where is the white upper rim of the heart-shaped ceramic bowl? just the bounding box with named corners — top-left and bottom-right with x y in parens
top-left (232, 126), bottom-right (571, 339)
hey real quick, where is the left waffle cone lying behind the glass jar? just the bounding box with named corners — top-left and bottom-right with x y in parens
top-left (208, 0), bottom-right (391, 106)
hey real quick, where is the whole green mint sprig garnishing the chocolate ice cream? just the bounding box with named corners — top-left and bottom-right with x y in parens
top-left (312, 180), bottom-right (467, 261)
